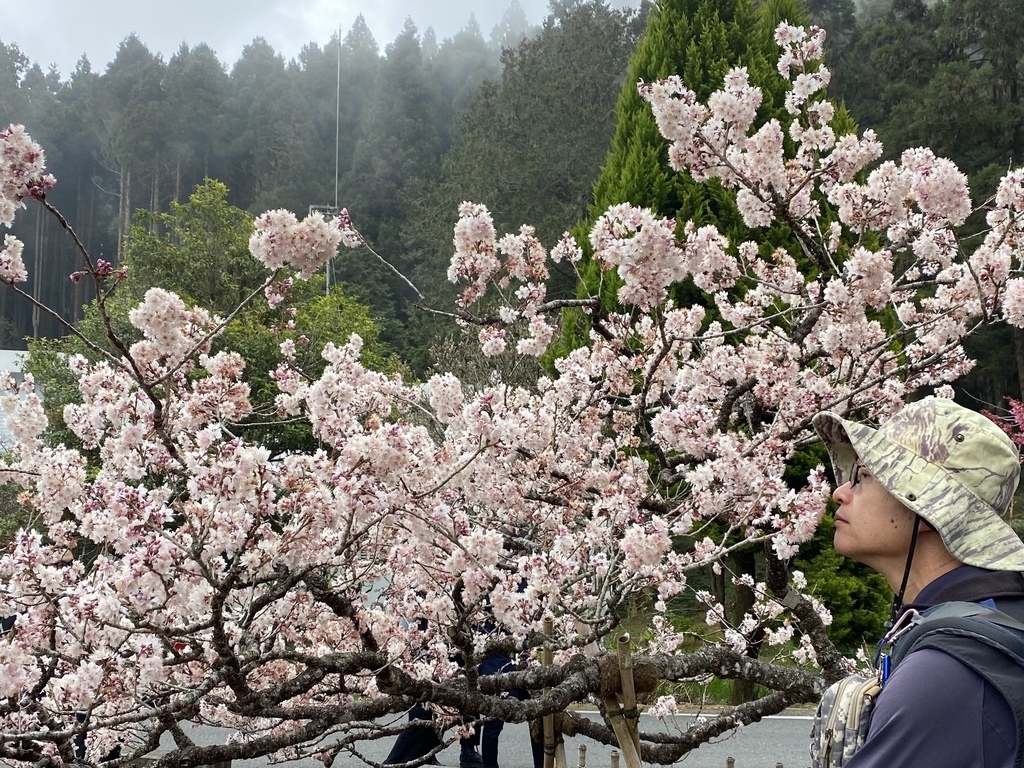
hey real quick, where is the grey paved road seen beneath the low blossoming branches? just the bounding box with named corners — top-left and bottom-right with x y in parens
top-left (146, 713), bottom-right (811, 768)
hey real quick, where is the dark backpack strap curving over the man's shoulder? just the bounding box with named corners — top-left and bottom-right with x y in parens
top-left (892, 602), bottom-right (1024, 768)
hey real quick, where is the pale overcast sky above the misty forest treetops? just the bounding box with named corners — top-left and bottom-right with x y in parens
top-left (0, 0), bottom-right (637, 78)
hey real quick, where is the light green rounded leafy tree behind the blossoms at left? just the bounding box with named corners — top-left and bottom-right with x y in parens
top-left (26, 179), bottom-right (403, 452)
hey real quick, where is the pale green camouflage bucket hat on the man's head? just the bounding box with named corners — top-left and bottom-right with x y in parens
top-left (813, 397), bottom-right (1024, 571)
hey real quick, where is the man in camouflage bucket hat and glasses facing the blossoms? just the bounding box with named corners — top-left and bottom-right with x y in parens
top-left (814, 397), bottom-right (1024, 768)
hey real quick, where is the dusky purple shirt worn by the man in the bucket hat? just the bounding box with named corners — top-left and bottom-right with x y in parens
top-left (846, 566), bottom-right (1017, 768)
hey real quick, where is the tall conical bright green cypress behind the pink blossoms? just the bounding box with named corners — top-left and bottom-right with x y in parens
top-left (553, 0), bottom-right (815, 339)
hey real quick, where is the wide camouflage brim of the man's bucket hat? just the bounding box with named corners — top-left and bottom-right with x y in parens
top-left (813, 413), bottom-right (1024, 571)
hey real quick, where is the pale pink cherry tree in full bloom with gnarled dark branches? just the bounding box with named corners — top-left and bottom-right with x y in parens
top-left (0, 25), bottom-right (1024, 768)
